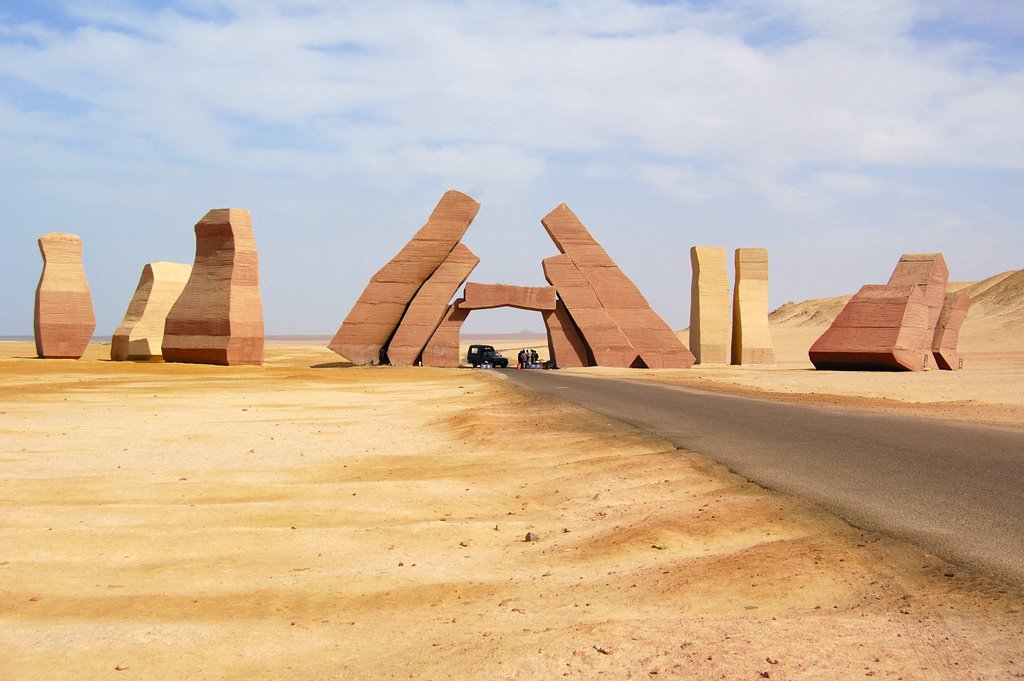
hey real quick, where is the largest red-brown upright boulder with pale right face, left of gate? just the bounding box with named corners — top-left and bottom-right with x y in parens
top-left (162, 208), bottom-right (263, 365)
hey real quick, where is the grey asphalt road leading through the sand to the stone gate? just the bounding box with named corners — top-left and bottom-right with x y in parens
top-left (502, 371), bottom-right (1024, 586)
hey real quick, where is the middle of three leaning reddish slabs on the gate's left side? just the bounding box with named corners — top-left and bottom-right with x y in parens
top-left (387, 244), bottom-right (480, 366)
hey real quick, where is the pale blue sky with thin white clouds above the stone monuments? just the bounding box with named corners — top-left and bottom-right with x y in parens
top-left (0, 0), bottom-right (1024, 335)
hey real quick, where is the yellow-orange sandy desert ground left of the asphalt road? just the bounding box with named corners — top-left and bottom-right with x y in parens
top-left (0, 341), bottom-right (1024, 679)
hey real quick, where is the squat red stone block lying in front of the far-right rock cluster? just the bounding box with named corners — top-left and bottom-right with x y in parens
top-left (808, 285), bottom-right (932, 371)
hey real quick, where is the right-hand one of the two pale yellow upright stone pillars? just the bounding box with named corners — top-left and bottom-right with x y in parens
top-left (732, 248), bottom-right (775, 365)
